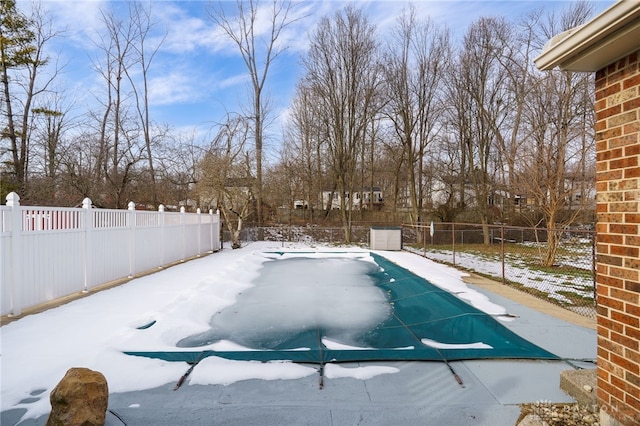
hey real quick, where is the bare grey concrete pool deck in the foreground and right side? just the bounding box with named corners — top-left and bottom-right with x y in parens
top-left (1, 266), bottom-right (597, 426)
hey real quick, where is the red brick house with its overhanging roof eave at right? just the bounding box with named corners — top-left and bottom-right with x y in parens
top-left (536, 0), bottom-right (640, 426)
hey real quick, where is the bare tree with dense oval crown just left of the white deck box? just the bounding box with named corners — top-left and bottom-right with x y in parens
top-left (303, 6), bottom-right (381, 243)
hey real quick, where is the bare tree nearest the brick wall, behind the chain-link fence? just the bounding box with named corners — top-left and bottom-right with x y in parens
top-left (519, 3), bottom-right (595, 266)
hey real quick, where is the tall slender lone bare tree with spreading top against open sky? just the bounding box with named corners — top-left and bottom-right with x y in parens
top-left (210, 0), bottom-right (294, 225)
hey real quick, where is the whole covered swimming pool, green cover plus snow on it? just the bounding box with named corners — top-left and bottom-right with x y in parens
top-left (125, 251), bottom-right (556, 365)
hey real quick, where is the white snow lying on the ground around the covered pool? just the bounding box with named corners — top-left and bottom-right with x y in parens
top-left (0, 242), bottom-right (506, 418)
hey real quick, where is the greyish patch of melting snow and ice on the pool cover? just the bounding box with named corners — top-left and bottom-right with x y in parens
top-left (177, 254), bottom-right (391, 349)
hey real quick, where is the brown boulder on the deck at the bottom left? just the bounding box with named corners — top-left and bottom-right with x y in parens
top-left (47, 368), bottom-right (109, 426)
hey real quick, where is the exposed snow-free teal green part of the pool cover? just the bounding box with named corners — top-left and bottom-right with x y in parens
top-left (125, 253), bottom-right (560, 364)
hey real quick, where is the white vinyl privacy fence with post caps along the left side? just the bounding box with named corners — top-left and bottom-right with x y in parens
top-left (0, 192), bottom-right (220, 315)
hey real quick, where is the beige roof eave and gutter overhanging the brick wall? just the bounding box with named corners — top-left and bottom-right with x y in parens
top-left (535, 0), bottom-right (640, 72)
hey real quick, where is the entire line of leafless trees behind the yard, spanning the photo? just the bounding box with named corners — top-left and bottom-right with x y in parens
top-left (0, 0), bottom-right (595, 253)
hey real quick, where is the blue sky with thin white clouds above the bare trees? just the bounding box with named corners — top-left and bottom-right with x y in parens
top-left (18, 0), bottom-right (614, 156)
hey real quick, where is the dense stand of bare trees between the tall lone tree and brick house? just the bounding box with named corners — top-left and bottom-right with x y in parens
top-left (277, 2), bottom-right (595, 251)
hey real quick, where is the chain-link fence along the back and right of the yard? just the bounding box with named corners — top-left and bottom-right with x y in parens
top-left (232, 223), bottom-right (596, 318)
